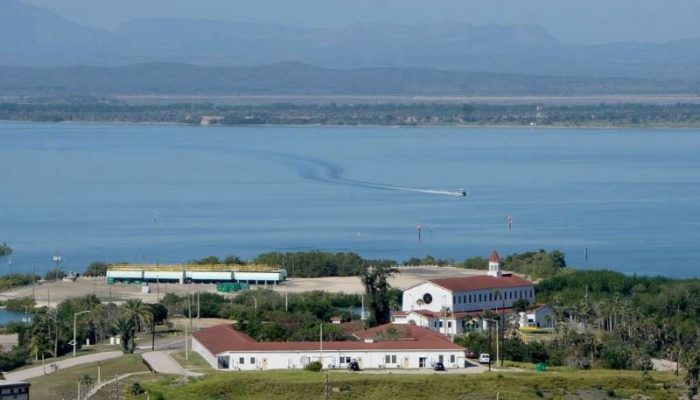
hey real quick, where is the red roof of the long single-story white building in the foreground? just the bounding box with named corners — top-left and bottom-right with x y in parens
top-left (192, 324), bottom-right (464, 354)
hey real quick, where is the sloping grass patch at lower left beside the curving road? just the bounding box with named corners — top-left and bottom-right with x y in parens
top-left (29, 354), bottom-right (148, 399)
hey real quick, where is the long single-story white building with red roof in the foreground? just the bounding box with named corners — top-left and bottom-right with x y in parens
top-left (192, 324), bottom-right (465, 370)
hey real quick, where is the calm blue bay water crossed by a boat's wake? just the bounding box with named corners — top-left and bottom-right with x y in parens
top-left (0, 123), bottom-right (700, 277)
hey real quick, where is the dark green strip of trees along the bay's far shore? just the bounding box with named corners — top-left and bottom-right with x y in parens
top-left (0, 101), bottom-right (700, 128)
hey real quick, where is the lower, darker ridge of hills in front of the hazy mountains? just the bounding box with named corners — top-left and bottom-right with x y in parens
top-left (0, 62), bottom-right (700, 96)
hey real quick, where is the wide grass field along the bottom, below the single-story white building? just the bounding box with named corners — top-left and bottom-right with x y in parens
top-left (143, 370), bottom-right (683, 400)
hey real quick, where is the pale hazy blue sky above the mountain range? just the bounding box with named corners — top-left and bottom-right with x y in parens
top-left (24, 0), bottom-right (700, 43)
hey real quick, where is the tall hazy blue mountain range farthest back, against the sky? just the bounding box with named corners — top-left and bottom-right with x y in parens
top-left (0, 0), bottom-right (700, 81)
